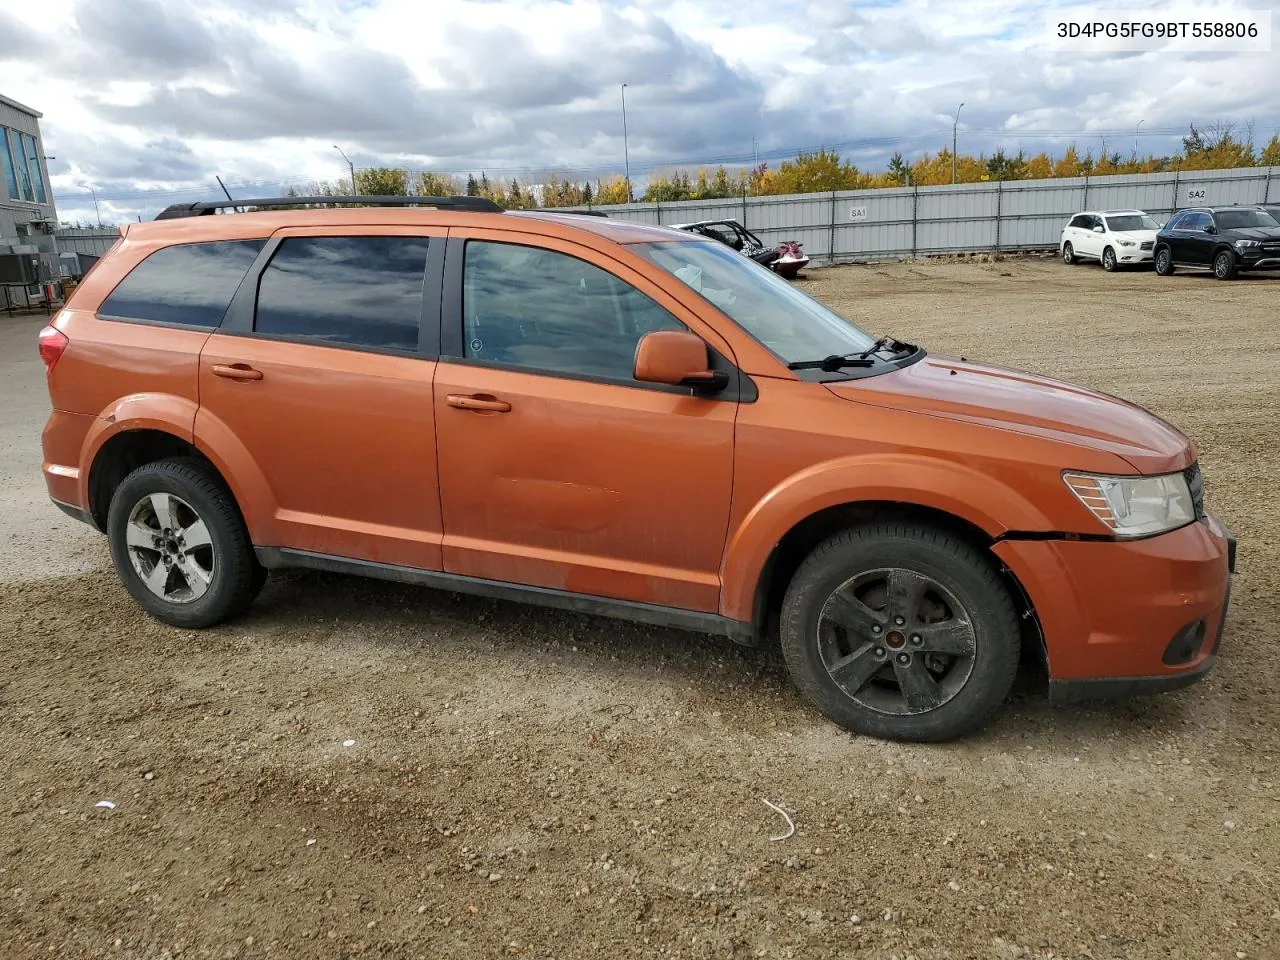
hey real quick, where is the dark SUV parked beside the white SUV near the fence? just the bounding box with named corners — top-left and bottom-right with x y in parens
top-left (1156, 206), bottom-right (1280, 280)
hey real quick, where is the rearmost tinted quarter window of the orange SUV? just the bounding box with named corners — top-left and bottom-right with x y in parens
top-left (97, 239), bottom-right (266, 326)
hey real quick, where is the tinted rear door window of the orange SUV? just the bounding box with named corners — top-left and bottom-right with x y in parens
top-left (253, 237), bottom-right (428, 351)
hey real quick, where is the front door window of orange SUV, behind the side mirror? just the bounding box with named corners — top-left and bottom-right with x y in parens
top-left (462, 241), bottom-right (680, 380)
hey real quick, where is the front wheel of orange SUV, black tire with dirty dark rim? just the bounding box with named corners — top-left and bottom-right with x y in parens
top-left (781, 524), bottom-right (1020, 741)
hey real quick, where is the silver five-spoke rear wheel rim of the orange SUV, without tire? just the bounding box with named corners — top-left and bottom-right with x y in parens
top-left (124, 493), bottom-right (215, 603)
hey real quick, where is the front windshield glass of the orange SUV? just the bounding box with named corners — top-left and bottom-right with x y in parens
top-left (631, 241), bottom-right (876, 364)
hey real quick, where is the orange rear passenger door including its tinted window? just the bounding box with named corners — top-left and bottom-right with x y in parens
top-left (196, 227), bottom-right (444, 570)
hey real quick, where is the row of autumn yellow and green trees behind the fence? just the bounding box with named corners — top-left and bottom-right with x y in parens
top-left (275, 123), bottom-right (1280, 210)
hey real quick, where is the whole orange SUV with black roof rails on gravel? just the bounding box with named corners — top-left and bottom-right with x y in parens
top-left (40, 197), bottom-right (1235, 740)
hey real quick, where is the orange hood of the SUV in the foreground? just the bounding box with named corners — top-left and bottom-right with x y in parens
top-left (827, 356), bottom-right (1196, 474)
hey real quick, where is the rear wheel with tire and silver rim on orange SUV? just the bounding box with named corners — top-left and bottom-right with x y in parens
top-left (106, 458), bottom-right (266, 628)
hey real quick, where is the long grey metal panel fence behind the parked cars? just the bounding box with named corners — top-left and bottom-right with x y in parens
top-left (573, 166), bottom-right (1280, 262)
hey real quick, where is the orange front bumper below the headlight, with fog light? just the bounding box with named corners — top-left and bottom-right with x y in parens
top-left (995, 516), bottom-right (1235, 700)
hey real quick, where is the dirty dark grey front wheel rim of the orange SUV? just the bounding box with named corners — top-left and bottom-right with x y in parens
top-left (818, 567), bottom-right (977, 716)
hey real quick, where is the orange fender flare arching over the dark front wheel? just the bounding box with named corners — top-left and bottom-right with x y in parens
top-left (721, 453), bottom-right (1050, 621)
